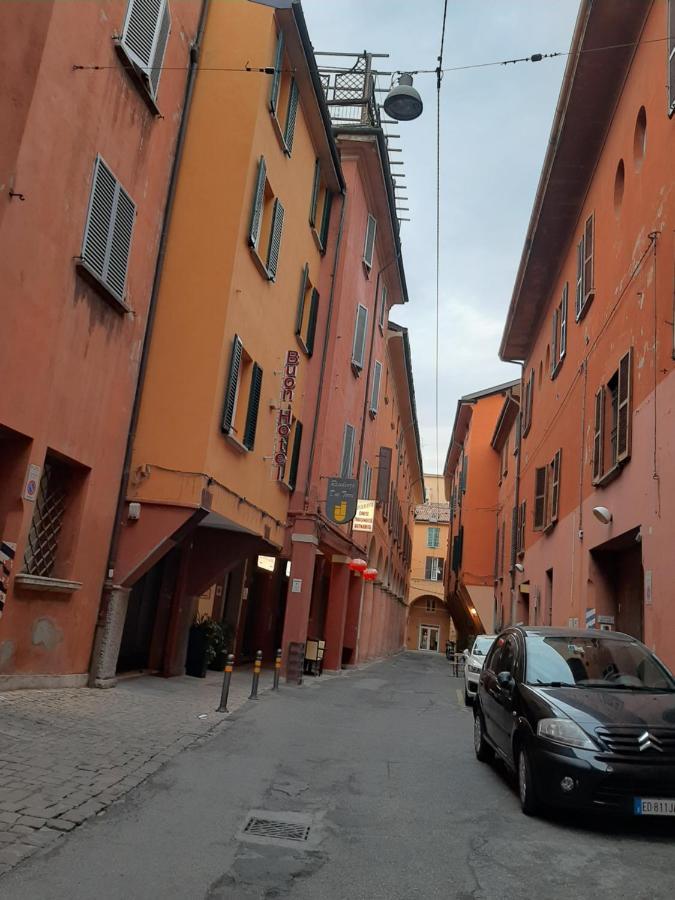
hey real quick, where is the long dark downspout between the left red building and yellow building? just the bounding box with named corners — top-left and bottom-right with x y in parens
top-left (93, 0), bottom-right (211, 660)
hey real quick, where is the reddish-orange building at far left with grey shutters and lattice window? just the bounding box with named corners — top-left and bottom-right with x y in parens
top-left (0, 0), bottom-right (201, 688)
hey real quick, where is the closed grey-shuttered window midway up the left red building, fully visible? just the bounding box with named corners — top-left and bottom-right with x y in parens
top-left (78, 156), bottom-right (136, 305)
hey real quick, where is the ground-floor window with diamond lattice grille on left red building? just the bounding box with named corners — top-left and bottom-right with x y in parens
top-left (23, 454), bottom-right (71, 578)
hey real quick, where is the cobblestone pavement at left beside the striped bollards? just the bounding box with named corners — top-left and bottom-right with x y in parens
top-left (0, 669), bottom-right (272, 876)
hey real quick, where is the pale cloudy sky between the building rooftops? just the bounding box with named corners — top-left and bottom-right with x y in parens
top-left (303, 0), bottom-right (578, 472)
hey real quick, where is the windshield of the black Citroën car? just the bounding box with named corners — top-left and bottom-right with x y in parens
top-left (526, 634), bottom-right (675, 691)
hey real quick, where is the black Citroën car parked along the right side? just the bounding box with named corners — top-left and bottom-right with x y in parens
top-left (474, 626), bottom-right (675, 816)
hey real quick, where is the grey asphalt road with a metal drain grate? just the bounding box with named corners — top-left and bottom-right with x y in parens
top-left (0, 653), bottom-right (675, 900)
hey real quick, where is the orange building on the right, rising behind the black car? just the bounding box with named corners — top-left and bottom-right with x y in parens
top-left (500, 0), bottom-right (675, 666)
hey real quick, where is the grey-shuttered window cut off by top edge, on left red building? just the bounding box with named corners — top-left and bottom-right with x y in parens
top-left (118, 0), bottom-right (171, 105)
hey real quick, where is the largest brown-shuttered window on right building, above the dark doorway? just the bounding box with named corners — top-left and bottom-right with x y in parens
top-left (593, 350), bottom-right (632, 484)
